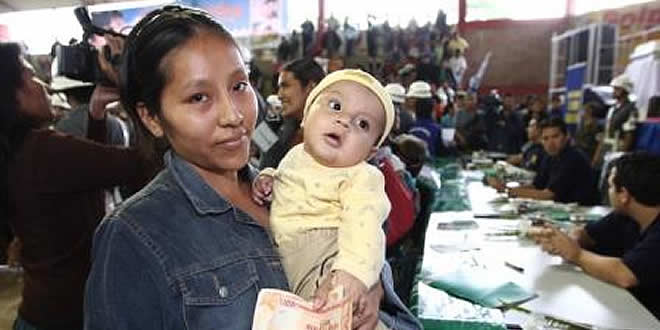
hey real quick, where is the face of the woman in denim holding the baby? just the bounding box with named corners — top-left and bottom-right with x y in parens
top-left (143, 31), bottom-right (257, 174)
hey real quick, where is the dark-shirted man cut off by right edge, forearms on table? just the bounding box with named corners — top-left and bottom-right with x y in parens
top-left (530, 153), bottom-right (660, 318)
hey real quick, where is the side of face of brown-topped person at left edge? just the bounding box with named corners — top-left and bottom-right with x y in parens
top-left (16, 67), bottom-right (53, 123)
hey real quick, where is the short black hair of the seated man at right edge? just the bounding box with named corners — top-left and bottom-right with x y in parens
top-left (613, 151), bottom-right (660, 207)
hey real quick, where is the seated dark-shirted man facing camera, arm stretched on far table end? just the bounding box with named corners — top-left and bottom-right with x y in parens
top-left (509, 117), bottom-right (598, 205)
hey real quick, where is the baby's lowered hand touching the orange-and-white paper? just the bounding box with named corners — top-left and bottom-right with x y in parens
top-left (314, 270), bottom-right (367, 314)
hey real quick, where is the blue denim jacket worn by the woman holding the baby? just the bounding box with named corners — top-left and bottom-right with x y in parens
top-left (84, 153), bottom-right (421, 330)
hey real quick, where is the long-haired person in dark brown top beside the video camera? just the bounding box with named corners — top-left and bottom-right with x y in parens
top-left (0, 43), bottom-right (150, 329)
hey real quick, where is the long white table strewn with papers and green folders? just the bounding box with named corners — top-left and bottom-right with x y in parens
top-left (410, 159), bottom-right (660, 329)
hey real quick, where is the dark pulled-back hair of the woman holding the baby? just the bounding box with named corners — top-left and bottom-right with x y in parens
top-left (119, 6), bottom-right (240, 166)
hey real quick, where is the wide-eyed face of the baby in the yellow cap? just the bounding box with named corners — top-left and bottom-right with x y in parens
top-left (304, 81), bottom-right (385, 167)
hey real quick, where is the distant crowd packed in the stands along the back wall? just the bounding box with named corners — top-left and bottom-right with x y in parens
top-left (277, 10), bottom-right (470, 92)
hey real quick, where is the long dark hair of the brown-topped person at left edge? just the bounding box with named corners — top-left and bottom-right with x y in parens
top-left (0, 43), bottom-right (33, 222)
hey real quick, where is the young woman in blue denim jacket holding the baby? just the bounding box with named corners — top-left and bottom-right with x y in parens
top-left (85, 6), bottom-right (417, 329)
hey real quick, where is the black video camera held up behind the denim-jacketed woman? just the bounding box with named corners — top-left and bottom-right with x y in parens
top-left (54, 7), bottom-right (125, 83)
